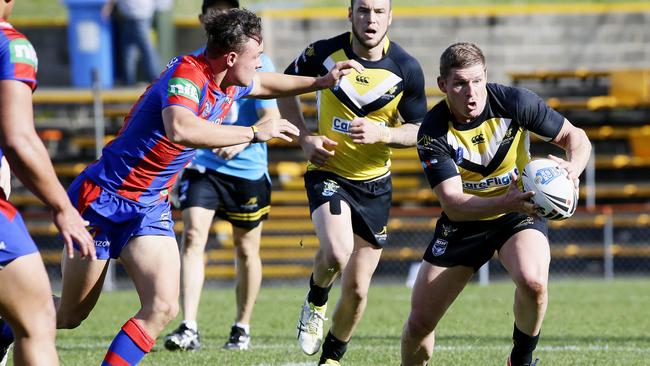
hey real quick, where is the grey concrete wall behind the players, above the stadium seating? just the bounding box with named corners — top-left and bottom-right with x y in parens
top-left (17, 6), bottom-right (650, 86)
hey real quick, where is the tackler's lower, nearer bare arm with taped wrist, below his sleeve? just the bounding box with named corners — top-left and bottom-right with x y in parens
top-left (162, 106), bottom-right (298, 148)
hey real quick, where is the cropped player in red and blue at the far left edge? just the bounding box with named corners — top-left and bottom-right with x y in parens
top-left (0, 0), bottom-right (95, 365)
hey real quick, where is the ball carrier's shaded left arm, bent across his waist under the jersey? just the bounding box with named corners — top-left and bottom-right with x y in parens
top-left (433, 175), bottom-right (535, 221)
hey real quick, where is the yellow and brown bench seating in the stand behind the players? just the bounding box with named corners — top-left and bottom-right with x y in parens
top-left (16, 76), bottom-right (650, 279)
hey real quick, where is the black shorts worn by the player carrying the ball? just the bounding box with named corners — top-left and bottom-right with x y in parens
top-left (424, 212), bottom-right (548, 271)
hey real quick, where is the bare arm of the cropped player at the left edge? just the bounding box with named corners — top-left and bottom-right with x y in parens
top-left (0, 80), bottom-right (95, 258)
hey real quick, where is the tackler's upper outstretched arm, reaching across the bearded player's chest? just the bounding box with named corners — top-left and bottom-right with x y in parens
top-left (249, 60), bottom-right (363, 98)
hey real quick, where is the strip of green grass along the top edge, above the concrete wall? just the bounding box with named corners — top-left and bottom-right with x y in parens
top-left (12, 0), bottom-right (646, 19)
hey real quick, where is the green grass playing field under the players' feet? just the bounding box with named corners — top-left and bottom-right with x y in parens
top-left (5, 279), bottom-right (650, 366)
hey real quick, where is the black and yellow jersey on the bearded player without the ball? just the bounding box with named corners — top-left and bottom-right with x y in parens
top-left (285, 32), bottom-right (427, 180)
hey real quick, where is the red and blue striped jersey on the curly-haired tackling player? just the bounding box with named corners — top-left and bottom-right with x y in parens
top-left (85, 54), bottom-right (253, 206)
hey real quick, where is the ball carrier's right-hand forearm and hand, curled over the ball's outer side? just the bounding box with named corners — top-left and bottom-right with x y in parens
top-left (549, 119), bottom-right (591, 187)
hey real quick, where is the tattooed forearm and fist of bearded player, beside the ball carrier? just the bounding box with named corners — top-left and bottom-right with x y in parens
top-left (350, 118), bottom-right (420, 148)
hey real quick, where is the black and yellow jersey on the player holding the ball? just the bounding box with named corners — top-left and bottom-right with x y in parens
top-left (417, 83), bottom-right (564, 219)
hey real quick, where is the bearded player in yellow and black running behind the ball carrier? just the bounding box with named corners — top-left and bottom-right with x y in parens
top-left (278, 0), bottom-right (426, 364)
